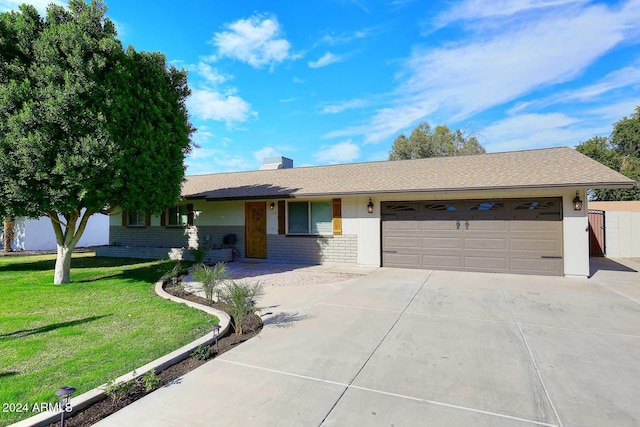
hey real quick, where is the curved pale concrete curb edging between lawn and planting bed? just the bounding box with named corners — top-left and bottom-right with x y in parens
top-left (9, 280), bottom-right (231, 427)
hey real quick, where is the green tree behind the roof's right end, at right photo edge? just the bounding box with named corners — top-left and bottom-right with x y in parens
top-left (576, 107), bottom-right (640, 200)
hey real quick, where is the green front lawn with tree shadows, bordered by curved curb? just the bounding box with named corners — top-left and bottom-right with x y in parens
top-left (0, 253), bottom-right (214, 426)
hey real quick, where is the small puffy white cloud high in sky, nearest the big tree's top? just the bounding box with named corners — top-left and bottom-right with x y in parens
top-left (213, 15), bottom-right (296, 68)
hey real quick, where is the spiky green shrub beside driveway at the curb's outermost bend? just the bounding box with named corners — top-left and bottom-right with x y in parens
top-left (220, 280), bottom-right (264, 335)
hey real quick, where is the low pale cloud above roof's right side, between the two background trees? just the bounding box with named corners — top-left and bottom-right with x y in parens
top-left (478, 113), bottom-right (611, 152)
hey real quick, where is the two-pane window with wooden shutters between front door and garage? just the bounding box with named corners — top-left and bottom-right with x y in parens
top-left (287, 201), bottom-right (333, 234)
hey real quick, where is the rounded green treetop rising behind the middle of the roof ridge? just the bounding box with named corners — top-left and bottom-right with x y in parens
top-left (389, 123), bottom-right (485, 160)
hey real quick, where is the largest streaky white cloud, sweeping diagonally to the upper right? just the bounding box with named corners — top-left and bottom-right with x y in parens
top-left (325, 2), bottom-right (640, 142)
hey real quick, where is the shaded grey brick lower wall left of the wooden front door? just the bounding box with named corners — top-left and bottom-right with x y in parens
top-left (109, 226), bottom-right (244, 257)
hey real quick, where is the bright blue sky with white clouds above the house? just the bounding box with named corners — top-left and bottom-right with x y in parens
top-left (0, 0), bottom-right (640, 174)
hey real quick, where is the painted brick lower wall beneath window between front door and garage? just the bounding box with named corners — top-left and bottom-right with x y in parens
top-left (267, 234), bottom-right (358, 264)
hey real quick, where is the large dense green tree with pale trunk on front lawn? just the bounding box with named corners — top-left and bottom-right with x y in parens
top-left (0, 0), bottom-right (194, 284)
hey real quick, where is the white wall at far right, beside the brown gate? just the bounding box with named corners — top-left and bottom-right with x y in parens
top-left (604, 211), bottom-right (640, 258)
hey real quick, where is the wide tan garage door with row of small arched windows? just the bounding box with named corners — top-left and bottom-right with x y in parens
top-left (382, 198), bottom-right (563, 275)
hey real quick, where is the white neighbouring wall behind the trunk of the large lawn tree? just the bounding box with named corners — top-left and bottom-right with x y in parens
top-left (3, 214), bottom-right (109, 251)
